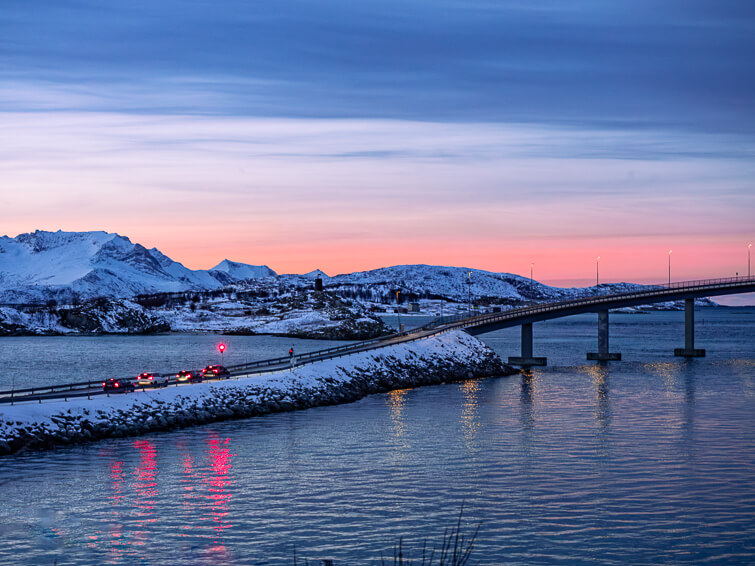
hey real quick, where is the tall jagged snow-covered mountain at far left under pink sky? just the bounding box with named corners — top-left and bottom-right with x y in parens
top-left (0, 230), bottom-right (275, 303)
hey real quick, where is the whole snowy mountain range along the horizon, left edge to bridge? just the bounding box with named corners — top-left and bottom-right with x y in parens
top-left (0, 230), bottom-right (704, 305)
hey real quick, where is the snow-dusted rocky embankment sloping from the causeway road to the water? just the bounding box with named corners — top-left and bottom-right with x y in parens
top-left (0, 331), bottom-right (518, 454)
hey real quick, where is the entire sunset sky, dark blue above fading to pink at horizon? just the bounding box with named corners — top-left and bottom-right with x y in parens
top-left (0, 0), bottom-right (755, 283)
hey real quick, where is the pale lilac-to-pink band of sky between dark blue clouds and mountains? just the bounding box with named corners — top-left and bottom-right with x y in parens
top-left (0, 112), bottom-right (755, 282)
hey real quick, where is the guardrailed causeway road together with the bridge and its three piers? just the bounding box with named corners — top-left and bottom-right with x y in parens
top-left (0, 277), bottom-right (755, 404)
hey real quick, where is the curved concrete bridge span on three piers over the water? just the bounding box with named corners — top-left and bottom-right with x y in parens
top-left (447, 276), bottom-right (755, 367)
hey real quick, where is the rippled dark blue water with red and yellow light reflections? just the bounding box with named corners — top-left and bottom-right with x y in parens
top-left (0, 309), bottom-right (755, 565)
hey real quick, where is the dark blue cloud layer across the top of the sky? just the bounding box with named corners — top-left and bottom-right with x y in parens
top-left (5, 0), bottom-right (755, 134)
